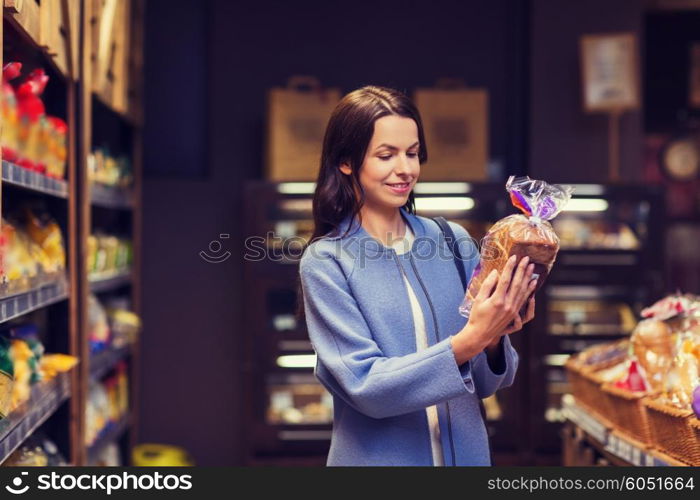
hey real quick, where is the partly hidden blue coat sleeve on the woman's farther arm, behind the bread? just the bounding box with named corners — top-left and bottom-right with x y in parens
top-left (449, 222), bottom-right (519, 399)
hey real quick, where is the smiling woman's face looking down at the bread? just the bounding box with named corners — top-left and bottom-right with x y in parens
top-left (340, 115), bottom-right (420, 208)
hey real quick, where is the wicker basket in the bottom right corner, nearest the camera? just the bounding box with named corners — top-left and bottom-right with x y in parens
top-left (644, 398), bottom-right (700, 465)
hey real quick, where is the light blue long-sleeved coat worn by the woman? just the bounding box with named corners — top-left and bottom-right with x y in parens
top-left (299, 208), bottom-right (518, 465)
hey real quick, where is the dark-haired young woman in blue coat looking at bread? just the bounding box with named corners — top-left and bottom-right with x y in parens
top-left (300, 87), bottom-right (535, 465)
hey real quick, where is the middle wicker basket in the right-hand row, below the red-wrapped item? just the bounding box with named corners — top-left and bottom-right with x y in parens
top-left (603, 384), bottom-right (652, 446)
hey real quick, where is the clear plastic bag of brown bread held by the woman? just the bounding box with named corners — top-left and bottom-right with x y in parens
top-left (459, 176), bottom-right (573, 318)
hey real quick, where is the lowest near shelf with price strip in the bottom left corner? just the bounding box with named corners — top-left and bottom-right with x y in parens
top-left (0, 372), bottom-right (71, 463)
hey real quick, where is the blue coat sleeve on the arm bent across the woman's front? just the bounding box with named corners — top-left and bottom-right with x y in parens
top-left (300, 249), bottom-right (475, 418)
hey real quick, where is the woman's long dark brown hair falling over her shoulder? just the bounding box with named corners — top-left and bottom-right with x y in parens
top-left (297, 86), bottom-right (428, 322)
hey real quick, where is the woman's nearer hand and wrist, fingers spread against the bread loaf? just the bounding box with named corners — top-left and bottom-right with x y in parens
top-left (452, 255), bottom-right (537, 365)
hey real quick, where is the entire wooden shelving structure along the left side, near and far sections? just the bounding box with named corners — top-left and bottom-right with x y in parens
top-left (0, 0), bottom-right (144, 465)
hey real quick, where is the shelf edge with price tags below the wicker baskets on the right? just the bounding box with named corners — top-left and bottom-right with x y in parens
top-left (562, 394), bottom-right (682, 467)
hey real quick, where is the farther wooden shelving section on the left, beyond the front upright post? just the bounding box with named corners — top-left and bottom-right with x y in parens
top-left (78, 0), bottom-right (143, 464)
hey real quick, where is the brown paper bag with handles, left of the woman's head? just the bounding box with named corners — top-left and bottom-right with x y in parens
top-left (265, 77), bottom-right (340, 181)
